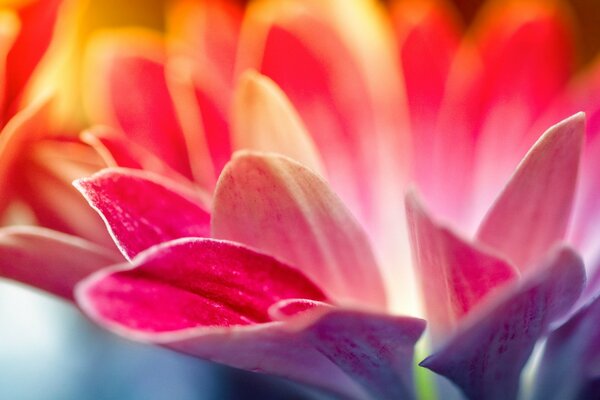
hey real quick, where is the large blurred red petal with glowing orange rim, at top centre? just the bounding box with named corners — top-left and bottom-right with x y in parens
top-left (240, 2), bottom-right (390, 221)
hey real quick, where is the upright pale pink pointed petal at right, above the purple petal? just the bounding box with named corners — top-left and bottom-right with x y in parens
top-left (477, 113), bottom-right (585, 270)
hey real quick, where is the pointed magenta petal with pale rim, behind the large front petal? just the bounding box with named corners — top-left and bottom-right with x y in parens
top-left (74, 168), bottom-right (210, 259)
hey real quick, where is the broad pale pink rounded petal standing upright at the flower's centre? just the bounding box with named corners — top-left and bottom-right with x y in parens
top-left (212, 152), bottom-right (385, 307)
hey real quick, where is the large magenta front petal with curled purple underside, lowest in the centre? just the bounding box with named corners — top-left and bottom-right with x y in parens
top-left (77, 239), bottom-right (424, 399)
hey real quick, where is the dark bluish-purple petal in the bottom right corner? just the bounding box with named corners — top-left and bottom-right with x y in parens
top-left (532, 297), bottom-right (600, 400)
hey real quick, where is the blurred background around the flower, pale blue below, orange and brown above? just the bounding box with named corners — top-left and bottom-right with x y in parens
top-left (0, 0), bottom-right (600, 400)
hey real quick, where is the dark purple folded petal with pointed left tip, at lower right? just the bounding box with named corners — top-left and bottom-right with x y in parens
top-left (421, 249), bottom-right (585, 400)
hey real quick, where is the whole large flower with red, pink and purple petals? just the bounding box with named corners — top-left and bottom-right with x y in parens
top-left (2, 0), bottom-right (600, 399)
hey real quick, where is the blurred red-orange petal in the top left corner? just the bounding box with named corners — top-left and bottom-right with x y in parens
top-left (2, 0), bottom-right (63, 117)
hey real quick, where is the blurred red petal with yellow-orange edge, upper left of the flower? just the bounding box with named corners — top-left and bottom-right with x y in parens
top-left (84, 31), bottom-right (192, 178)
